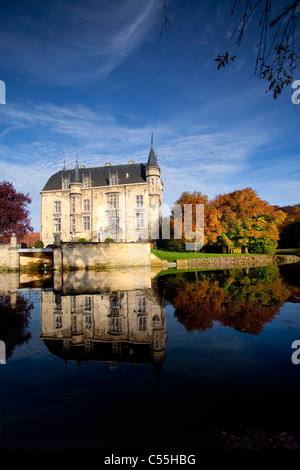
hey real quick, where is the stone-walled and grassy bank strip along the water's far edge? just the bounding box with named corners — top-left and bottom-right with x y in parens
top-left (0, 237), bottom-right (300, 272)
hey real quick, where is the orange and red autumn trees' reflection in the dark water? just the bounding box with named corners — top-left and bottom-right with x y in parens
top-left (161, 265), bottom-right (291, 335)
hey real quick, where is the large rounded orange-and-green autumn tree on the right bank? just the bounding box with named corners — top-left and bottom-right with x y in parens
top-left (212, 188), bottom-right (285, 254)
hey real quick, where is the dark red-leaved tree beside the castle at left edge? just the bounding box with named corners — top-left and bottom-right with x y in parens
top-left (0, 181), bottom-right (33, 243)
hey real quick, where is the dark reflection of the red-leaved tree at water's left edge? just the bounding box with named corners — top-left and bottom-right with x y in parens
top-left (0, 295), bottom-right (33, 359)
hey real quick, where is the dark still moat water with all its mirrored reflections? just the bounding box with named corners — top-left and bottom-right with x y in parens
top-left (0, 263), bottom-right (300, 454)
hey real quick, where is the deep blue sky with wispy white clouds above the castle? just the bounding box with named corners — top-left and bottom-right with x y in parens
top-left (0, 0), bottom-right (300, 231)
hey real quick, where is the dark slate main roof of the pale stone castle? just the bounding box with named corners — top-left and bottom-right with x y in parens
top-left (42, 162), bottom-right (149, 191)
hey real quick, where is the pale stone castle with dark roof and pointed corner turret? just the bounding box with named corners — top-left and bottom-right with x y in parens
top-left (40, 140), bottom-right (163, 246)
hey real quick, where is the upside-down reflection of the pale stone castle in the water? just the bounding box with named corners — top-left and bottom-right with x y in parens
top-left (40, 269), bottom-right (167, 364)
